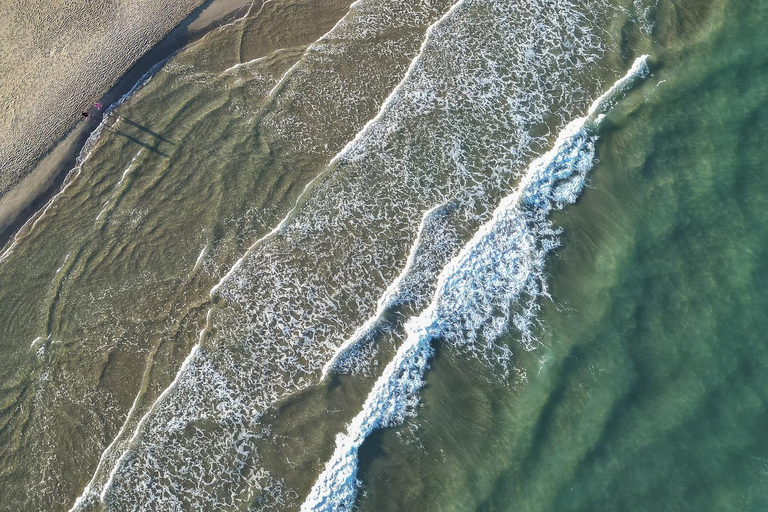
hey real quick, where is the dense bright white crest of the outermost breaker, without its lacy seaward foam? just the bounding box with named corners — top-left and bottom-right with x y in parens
top-left (301, 55), bottom-right (649, 512)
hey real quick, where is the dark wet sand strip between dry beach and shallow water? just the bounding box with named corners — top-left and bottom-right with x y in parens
top-left (0, 0), bottom-right (262, 252)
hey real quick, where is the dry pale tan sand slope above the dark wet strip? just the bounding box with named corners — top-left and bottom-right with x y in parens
top-left (0, 0), bottom-right (208, 227)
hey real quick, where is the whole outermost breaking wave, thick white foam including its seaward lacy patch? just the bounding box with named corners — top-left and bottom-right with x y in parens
top-left (301, 56), bottom-right (648, 511)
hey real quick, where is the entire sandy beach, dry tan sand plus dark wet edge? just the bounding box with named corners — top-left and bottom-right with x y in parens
top-left (0, 0), bottom-right (253, 244)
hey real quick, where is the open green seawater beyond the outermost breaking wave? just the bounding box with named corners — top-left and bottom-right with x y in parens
top-left (361, 2), bottom-right (768, 511)
